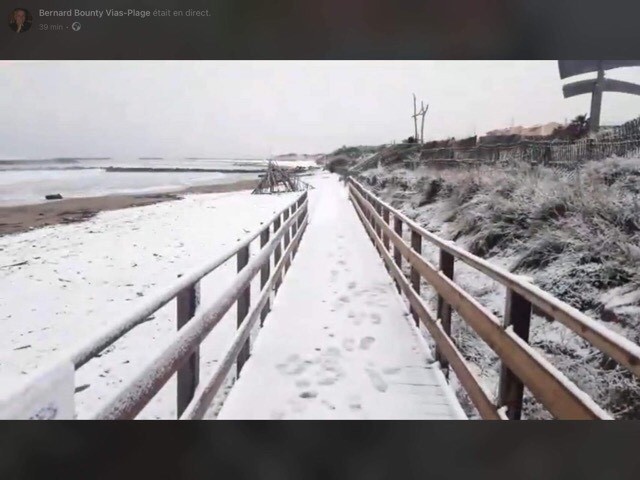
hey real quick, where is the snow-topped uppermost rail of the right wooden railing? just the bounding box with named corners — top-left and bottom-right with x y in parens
top-left (351, 179), bottom-right (640, 378)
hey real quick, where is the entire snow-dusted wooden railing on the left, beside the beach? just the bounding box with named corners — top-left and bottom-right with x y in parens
top-left (66, 192), bottom-right (308, 419)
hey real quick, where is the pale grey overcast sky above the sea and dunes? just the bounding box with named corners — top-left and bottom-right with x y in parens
top-left (0, 61), bottom-right (640, 158)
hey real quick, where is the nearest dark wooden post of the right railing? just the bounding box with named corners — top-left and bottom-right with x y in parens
top-left (498, 288), bottom-right (531, 420)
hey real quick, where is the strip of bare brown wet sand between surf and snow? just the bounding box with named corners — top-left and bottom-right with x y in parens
top-left (0, 179), bottom-right (258, 236)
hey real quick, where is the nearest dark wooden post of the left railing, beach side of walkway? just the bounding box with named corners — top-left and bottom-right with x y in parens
top-left (176, 282), bottom-right (200, 417)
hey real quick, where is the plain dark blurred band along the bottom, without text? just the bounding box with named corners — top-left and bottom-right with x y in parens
top-left (0, 421), bottom-right (640, 480)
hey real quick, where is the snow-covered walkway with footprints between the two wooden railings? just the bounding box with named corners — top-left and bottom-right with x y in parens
top-left (218, 177), bottom-right (464, 419)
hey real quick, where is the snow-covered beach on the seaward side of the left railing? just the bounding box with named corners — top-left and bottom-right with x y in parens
top-left (0, 187), bottom-right (297, 418)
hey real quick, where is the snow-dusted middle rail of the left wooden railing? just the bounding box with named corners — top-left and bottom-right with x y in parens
top-left (95, 195), bottom-right (308, 420)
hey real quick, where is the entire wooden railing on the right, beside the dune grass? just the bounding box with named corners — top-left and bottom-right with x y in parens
top-left (348, 178), bottom-right (640, 419)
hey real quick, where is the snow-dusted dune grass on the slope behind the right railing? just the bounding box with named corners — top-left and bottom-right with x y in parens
top-left (363, 158), bottom-right (640, 418)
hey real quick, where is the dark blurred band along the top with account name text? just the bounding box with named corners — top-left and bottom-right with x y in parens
top-left (0, 0), bottom-right (640, 60)
